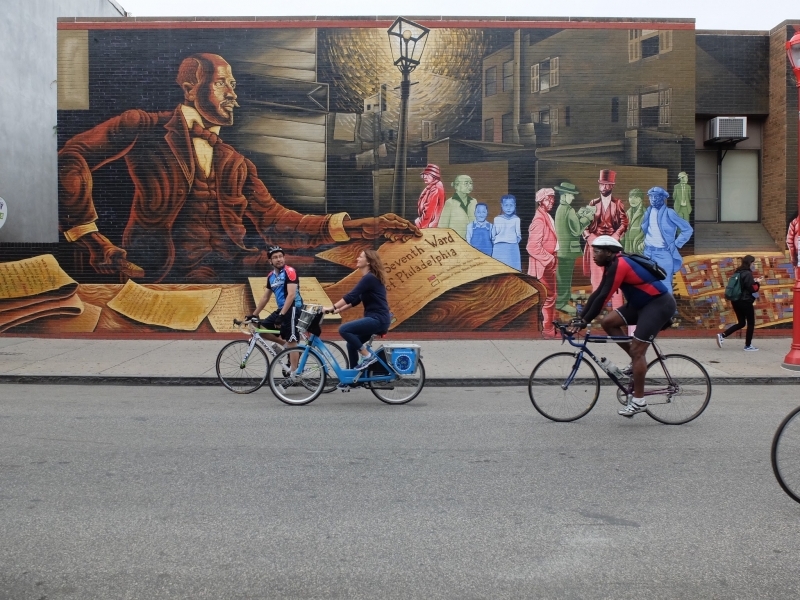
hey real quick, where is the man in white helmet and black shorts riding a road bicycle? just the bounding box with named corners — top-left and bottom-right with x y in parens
top-left (568, 235), bottom-right (676, 418)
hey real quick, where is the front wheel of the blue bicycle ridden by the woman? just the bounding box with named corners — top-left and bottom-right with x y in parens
top-left (267, 346), bottom-right (325, 406)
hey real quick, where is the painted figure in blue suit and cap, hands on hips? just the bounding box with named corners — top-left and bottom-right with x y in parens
top-left (642, 187), bottom-right (693, 294)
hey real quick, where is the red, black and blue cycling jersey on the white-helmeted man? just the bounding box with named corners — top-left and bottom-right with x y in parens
top-left (581, 254), bottom-right (672, 323)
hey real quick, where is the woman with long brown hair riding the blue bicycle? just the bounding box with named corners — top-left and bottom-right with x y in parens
top-left (323, 250), bottom-right (391, 370)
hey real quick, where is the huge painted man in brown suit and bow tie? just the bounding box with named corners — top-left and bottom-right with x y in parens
top-left (59, 54), bottom-right (421, 283)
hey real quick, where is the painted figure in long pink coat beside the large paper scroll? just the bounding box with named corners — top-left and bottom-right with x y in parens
top-left (526, 188), bottom-right (558, 339)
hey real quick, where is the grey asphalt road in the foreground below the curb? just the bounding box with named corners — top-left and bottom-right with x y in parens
top-left (0, 385), bottom-right (800, 600)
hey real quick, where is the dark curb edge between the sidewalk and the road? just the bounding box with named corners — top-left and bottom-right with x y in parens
top-left (0, 375), bottom-right (800, 388)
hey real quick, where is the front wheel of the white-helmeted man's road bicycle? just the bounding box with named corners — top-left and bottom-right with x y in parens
top-left (528, 352), bottom-right (600, 422)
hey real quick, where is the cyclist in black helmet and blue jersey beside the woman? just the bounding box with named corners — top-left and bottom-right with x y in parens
top-left (246, 246), bottom-right (303, 371)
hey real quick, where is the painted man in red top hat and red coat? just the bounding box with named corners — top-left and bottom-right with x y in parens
top-left (583, 169), bottom-right (628, 308)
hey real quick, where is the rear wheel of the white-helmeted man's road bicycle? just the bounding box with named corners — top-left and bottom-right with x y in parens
top-left (644, 354), bottom-right (711, 425)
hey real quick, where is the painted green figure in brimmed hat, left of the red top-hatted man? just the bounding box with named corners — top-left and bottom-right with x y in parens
top-left (553, 181), bottom-right (593, 315)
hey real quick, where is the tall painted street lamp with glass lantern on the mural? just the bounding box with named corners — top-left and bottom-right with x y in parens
top-left (387, 17), bottom-right (430, 217)
